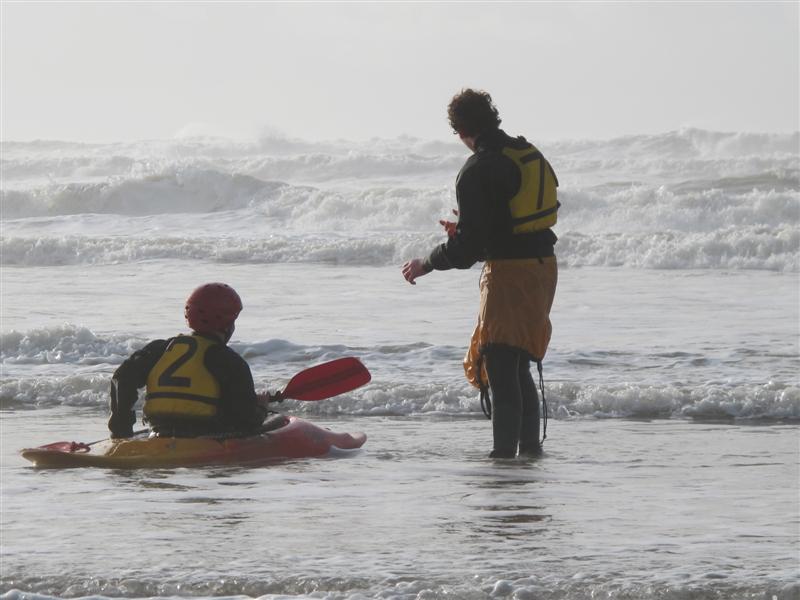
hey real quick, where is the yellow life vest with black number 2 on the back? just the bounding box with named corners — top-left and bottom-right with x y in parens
top-left (144, 335), bottom-right (221, 419)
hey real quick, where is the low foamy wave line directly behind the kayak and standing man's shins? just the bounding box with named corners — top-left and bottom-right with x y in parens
top-left (0, 373), bottom-right (800, 421)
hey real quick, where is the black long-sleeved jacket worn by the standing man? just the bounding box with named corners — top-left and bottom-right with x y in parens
top-left (425, 129), bottom-right (557, 271)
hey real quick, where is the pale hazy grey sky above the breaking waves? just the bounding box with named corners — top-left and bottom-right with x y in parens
top-left (2, 0), bottom-right (800, 141)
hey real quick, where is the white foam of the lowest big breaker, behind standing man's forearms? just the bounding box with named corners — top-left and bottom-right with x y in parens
top-left (0, 225), bottom-right (800, 272)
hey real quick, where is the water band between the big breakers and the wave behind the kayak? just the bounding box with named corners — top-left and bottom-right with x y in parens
top-left (0, 261), bottom-right (800, 410)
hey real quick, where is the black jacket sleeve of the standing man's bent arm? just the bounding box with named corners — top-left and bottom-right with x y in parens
top-left (425, 157), bottom-right (493, 271)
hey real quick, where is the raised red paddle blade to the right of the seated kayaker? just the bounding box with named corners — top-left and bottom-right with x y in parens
top-left (282, 357), bottom-right (372, 400)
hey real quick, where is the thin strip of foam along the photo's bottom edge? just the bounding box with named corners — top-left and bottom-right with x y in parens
top-left (0, 573), bottom-right (798, 600)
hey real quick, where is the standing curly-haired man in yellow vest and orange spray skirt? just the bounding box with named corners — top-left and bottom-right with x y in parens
top-left (402, 89), bottom-right (559, 458)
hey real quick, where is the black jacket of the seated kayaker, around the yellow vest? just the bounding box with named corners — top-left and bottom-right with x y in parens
top-left (108, 338), bottom-right (267, 438)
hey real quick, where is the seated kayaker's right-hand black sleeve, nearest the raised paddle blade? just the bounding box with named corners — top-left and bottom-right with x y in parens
top-left (206, 345), bottom-right (267, 432)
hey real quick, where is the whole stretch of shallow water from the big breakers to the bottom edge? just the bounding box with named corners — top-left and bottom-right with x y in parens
top-left (0, 262), bottom-right (800, 600)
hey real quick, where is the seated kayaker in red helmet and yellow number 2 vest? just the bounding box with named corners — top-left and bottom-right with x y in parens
top-left (108, 283), bottom-right (269, 438)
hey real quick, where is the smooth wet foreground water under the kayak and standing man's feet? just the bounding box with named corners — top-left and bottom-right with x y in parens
top-left (2, 409), bottom-right (800, 598)
